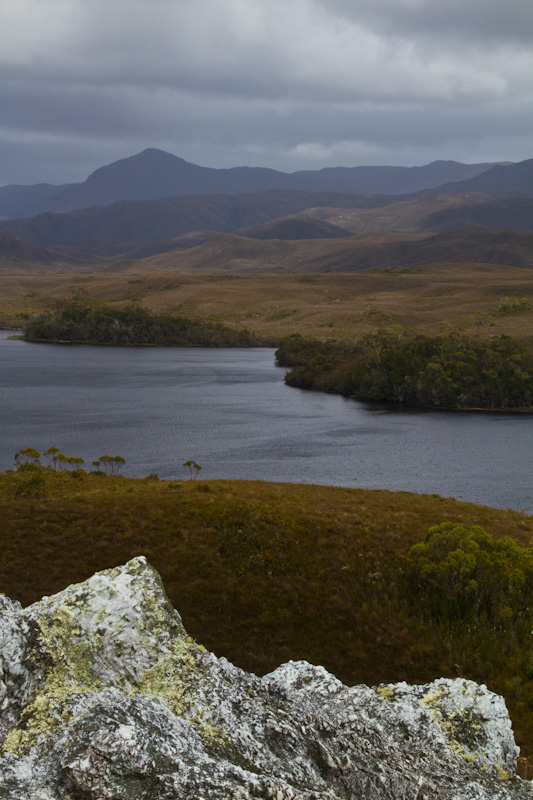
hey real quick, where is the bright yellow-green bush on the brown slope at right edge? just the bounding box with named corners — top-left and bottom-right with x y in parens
top-left (405, 522), bottom-right (533, 750)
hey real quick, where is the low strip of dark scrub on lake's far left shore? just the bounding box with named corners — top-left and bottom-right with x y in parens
top-left (24, 297), bottom-right (267, 347)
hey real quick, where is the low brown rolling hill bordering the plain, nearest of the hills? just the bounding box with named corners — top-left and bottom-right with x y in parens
top-left (131, 227), bottom-right (533, 274)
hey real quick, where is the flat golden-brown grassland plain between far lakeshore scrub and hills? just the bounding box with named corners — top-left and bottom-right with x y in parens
top-left (0, 264), bottom-right (533, 347)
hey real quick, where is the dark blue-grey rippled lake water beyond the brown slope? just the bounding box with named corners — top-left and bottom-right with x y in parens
top-left (0, 331), bottom-right (533, 513)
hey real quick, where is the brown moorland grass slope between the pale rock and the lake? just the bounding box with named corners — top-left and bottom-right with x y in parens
top-left (0, 470), bottom-right (533, 755)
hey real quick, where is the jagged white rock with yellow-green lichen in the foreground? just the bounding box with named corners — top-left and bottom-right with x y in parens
top-left (0, 558), bottom-right (533, 800)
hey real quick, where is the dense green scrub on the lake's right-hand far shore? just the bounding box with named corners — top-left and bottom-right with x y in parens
top-left (276, 330), bottom-right (533, 410)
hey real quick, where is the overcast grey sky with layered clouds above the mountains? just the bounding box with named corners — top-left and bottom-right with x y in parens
top-left (0, 0), bottom-right (533, 185)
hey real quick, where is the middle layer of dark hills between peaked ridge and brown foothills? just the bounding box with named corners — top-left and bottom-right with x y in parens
top-left (1, 190), bottom-right (533, 257)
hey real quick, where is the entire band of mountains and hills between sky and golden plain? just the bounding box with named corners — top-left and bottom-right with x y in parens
top-left (0, 150), bottom-right (533, 272)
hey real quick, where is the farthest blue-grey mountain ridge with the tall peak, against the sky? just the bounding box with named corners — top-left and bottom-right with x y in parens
top-left (0, 148), bottom-right (508, 219)
